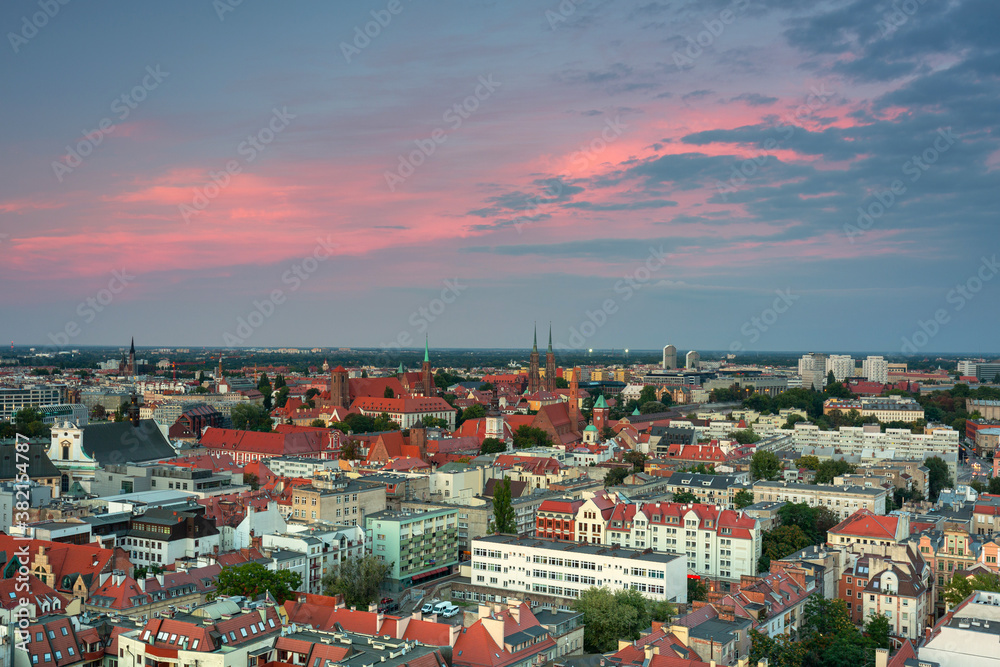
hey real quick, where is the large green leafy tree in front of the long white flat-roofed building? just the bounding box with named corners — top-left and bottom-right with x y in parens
top-left (573, 586), bottom-right (650, 653)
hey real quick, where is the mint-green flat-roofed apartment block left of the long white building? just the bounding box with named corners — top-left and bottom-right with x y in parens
top-left (365, 509), bottom-right (459, 592)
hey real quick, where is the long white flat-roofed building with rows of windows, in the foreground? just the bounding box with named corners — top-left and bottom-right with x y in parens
top-left (471, 535), bottom-right (687, 604)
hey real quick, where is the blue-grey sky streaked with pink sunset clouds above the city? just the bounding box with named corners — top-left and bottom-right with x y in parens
top-left (0, 0), bottom-right (1000, 355)
